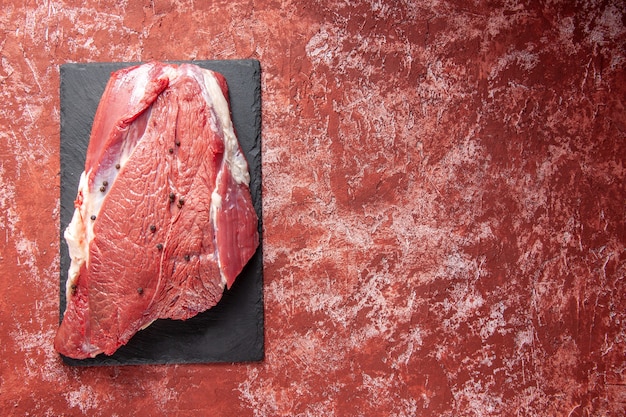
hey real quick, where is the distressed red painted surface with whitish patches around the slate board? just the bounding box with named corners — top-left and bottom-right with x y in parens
top-left (0, 0), bottom-right (626, 416)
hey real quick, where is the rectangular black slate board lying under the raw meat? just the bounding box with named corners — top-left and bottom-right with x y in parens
top-left (60, 60), bottom-right (264, 366)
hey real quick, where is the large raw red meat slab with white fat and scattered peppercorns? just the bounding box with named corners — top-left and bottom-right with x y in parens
top-left (54, 62), bottom-right (259, 359)
